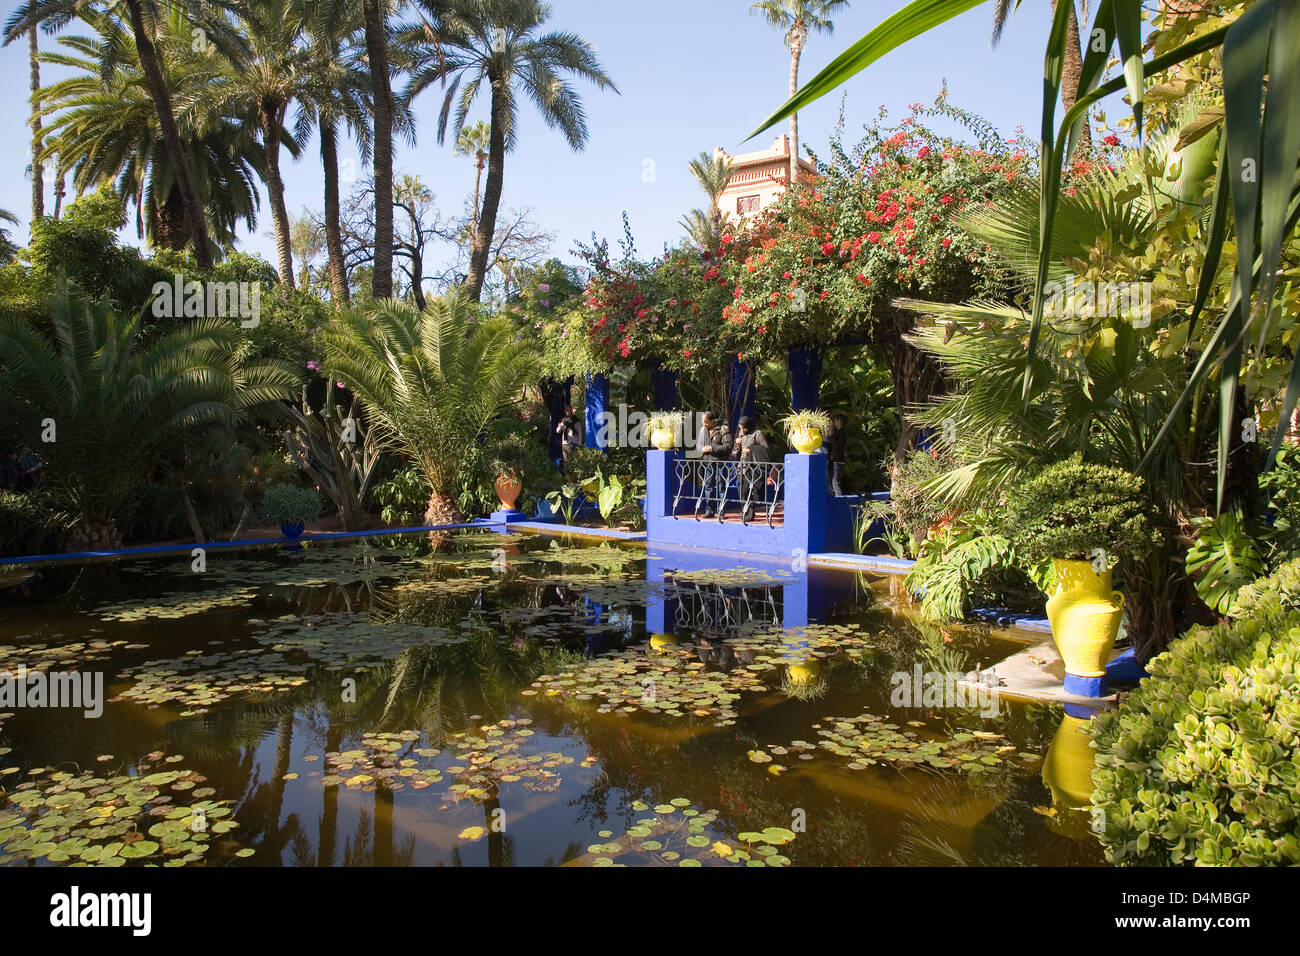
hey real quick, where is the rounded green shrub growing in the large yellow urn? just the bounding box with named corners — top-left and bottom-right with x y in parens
top-left (1000, 455), bottom-right (1165, 563)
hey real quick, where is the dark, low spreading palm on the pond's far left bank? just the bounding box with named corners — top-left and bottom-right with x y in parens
top-left (0, 281), bottom-right (299, 546)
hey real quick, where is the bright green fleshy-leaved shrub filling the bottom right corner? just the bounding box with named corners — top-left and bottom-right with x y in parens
top-left (1089, 609), bottom-right (1300, 866)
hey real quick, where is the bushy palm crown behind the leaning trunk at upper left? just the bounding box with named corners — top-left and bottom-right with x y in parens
top-left (39, 12), bottom-right (265, 250)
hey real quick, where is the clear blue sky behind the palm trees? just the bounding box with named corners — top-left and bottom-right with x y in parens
top-left (0, 0), bottom-right (1076, 270)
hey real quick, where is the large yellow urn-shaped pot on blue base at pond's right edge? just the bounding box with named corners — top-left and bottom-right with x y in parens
top-left (1048, 558), bottom-right (1125, 696)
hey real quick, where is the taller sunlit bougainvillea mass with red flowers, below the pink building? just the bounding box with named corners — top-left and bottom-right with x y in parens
top-left (723, 96), bottom-right (1031, 356)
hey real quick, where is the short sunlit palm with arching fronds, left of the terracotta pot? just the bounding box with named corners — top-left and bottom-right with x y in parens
top-left (322, 289), bottom-right (537, 545)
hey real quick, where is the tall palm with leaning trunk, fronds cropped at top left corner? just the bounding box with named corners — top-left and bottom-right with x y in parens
top-left (4, 0), bottom-right (212, 268)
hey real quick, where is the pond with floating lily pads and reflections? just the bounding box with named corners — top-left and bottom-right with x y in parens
top-left (0, 532), bottom-right (1102, 866)
